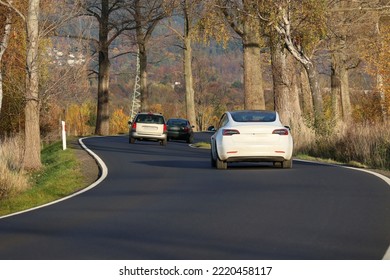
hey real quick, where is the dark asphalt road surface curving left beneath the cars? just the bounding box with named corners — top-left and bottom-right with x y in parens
top-left (0, 134), bottom-right (390, 260)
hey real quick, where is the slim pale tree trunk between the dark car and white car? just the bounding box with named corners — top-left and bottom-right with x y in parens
top-left (184, 36), bottom-right (196, 131)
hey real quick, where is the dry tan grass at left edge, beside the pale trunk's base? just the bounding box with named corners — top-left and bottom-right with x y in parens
top-left (0, 137), bottom-right (30, 200)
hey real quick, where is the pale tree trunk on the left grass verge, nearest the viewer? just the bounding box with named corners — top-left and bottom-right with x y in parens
top-left (23, 0), bottom-right (42, 170)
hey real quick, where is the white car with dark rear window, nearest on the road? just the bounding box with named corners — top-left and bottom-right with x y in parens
top-left (211, 110), bottom-right (293, 169)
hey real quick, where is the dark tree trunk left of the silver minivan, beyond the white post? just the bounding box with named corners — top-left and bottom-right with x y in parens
top-left (95, 0), bottom-right (110, 135)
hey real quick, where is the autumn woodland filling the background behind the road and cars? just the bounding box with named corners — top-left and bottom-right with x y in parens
top-left (0, 0), bottom-right (390, 190)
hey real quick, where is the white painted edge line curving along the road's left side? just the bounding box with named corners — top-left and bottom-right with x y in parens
top-left (0, 136), bottom-right (108, 220)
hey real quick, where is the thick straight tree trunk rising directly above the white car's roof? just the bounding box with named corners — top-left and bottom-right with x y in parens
top-left (243, 27), bottom-right (265, 110)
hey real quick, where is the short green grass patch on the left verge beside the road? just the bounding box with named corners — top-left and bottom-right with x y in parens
top-left (0, 142), bottom-right (85, 216)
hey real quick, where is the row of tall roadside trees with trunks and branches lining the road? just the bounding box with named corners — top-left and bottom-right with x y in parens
top-left (0, 0), bottom-right (390, 169)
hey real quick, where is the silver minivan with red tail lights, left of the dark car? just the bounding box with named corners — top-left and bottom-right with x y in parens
top-left (129, 113), bottom-right (167, 146)
